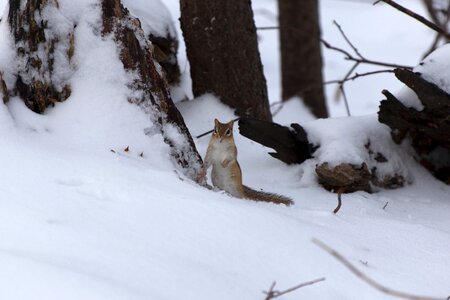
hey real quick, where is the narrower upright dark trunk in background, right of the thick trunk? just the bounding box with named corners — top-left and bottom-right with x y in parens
top-left (278, 0), bottom-right (328, 118)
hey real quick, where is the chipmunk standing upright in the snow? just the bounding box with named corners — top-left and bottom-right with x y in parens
top-left (197, 119), bottom-right (294, 206)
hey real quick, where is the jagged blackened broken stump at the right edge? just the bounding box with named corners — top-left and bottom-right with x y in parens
top-left (378, 69), bottom-right (450, 184)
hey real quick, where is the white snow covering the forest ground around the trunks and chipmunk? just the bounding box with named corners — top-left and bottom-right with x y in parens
top-left (0, 0), bottom-right (450, 300)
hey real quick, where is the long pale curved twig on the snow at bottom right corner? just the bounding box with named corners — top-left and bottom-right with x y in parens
top-left (312, 239), bottom-right (448, 300)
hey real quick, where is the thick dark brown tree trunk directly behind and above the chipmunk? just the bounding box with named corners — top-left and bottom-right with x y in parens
top-left (180, 0), bottom-right (272, 120)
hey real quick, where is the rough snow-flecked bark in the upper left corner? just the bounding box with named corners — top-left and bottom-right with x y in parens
top-left (4, 0), bottom-right (74, 113)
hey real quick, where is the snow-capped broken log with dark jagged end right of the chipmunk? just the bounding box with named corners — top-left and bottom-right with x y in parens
top-left (239, 115), bottom-right (408, 193)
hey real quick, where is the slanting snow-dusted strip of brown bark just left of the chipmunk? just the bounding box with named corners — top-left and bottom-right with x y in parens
top-left (102, 0), bottom-right (202, 179)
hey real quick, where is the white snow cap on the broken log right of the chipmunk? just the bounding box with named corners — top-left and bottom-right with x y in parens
top-left (303, 114), bottom-right (411, 185)
